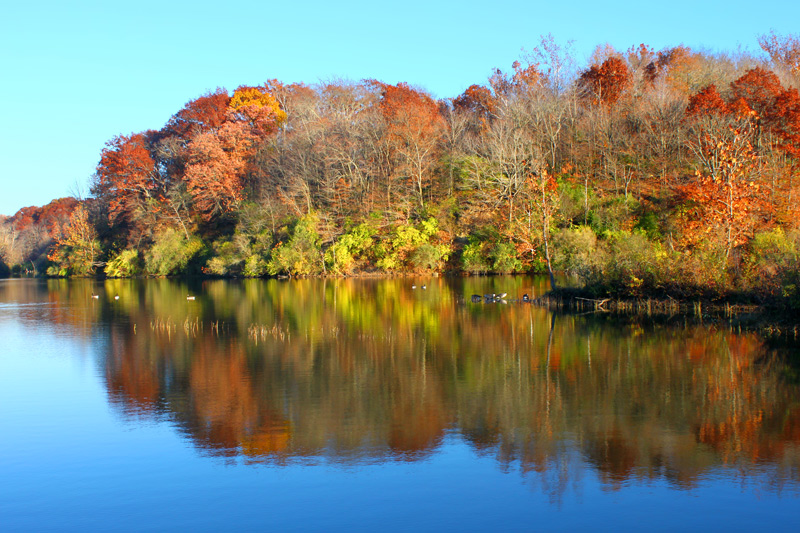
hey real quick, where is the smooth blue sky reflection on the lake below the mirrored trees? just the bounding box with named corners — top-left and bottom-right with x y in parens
top-left (0, 302), bottom-right (800, 531)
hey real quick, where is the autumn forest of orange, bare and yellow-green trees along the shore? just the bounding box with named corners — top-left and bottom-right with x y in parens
top-left (0, 32), bottom-right (800, 308)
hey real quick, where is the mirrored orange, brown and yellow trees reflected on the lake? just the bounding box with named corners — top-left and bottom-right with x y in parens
top-left (0, 278), bottom-right (800, 494)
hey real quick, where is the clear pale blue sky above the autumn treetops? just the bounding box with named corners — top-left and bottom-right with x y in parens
top-left (0, 0), bottom-right (800, 215)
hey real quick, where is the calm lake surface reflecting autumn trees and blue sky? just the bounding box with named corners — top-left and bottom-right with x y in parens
top-left (0, 277), bottom-right (800, 531)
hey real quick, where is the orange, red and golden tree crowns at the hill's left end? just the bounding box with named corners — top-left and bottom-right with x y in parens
top-left (99, 85), bottom-right (286, 230)
